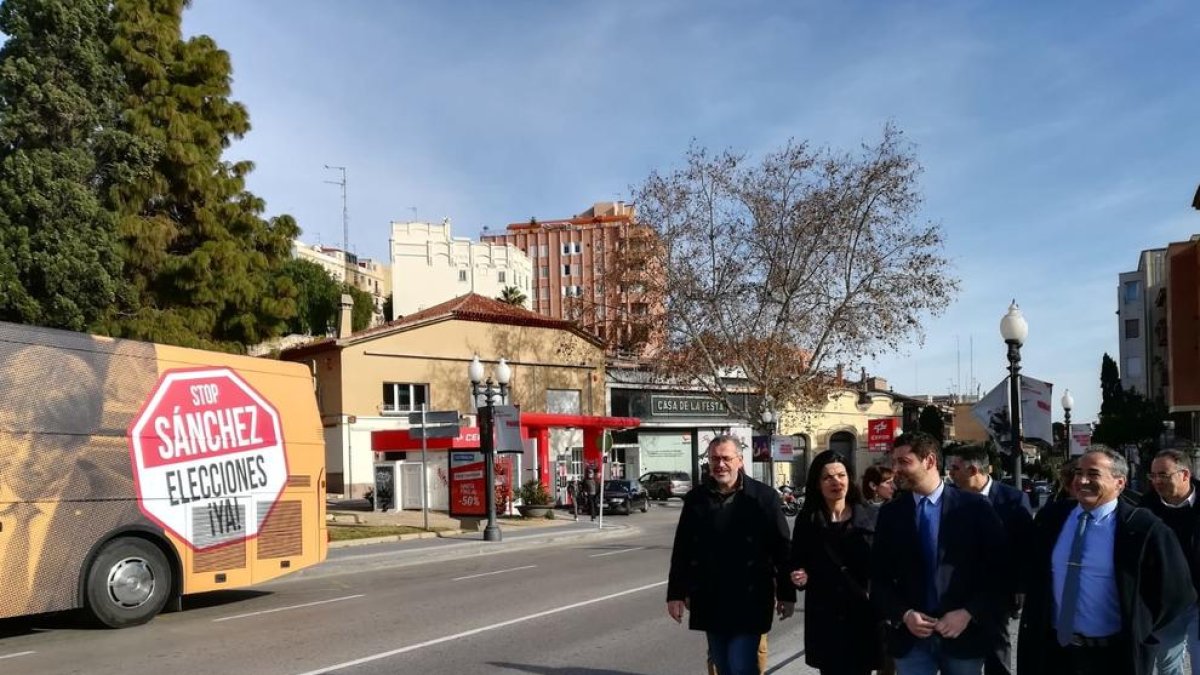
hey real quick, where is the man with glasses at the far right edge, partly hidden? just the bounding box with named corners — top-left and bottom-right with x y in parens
top-left (1141, 450), bottom-right (1200, 675)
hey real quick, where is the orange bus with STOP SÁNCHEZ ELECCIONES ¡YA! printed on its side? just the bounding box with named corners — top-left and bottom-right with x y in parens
top-left (0, 322), bottom-right (328, 628)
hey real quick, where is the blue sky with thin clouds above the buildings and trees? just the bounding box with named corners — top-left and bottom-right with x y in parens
top-left (185, 0), bottom-right (1200, 422)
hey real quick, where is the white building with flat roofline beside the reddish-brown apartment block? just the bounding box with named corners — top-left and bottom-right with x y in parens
top-left (389, 219), bottom-right (533, 318)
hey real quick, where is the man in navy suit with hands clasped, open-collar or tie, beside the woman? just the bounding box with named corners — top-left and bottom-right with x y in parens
top-left (871, 432), bottom-right (1004, 675)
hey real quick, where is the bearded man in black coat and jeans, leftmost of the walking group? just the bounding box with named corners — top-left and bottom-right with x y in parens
top-left (667, 436), bottom-right (796, 675)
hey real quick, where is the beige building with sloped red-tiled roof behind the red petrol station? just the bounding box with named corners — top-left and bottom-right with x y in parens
top-left (281, 294), bottom-right (605, 497)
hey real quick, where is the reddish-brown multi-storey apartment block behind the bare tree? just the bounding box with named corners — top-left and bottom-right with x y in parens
top-left (480, 202), bottom-right (654, 352)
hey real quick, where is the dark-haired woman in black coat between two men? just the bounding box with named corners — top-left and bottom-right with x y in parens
top-left (792, 450), bottom-right (882, 675)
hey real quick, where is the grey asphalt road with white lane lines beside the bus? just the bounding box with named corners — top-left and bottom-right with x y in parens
top-left (0, 502), bottom-right (811, 675)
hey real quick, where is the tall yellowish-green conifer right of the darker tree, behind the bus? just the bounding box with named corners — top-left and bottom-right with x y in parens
top-left (108, 0), bottom-right (299, 351)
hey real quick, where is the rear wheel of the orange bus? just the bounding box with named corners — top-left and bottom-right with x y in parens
top-left (88, 537), bottom-right (172, 628)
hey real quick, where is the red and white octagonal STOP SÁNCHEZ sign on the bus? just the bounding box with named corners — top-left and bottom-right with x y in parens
top-left (128, 368), bottom-right (288, 550)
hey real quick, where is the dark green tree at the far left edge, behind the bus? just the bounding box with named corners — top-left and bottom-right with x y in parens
top-left (0, 0), bottom-right (136, 330)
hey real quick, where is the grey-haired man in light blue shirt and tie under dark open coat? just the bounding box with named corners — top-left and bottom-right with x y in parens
top-left (1016, 446), bottom-right (1196, 675)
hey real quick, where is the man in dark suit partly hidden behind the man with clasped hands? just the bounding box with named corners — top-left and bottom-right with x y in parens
top-left (946, 446), bottom-right (1033, 675)
